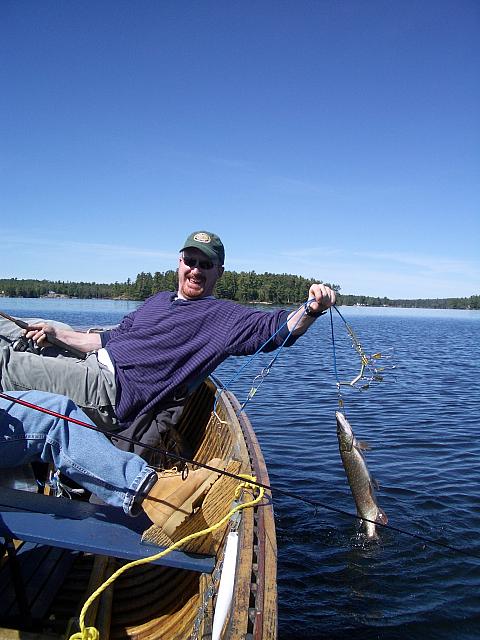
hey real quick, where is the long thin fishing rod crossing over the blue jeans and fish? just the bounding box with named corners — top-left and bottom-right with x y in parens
top-left (0, 392), bottom-right (480, 559)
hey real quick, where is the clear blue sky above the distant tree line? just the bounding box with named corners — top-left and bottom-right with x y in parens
top-left (0, 0), bottom-right (480, 298)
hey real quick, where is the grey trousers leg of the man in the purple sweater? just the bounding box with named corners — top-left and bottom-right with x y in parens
top-left (0, 347), bottom-right (117, 430)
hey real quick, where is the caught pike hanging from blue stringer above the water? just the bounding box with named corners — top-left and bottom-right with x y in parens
top-left (335, 411), bottom-right (388, 538)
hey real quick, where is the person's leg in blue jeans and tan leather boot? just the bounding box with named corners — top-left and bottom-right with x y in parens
top-left (0, 391), bottom-right (222, 536)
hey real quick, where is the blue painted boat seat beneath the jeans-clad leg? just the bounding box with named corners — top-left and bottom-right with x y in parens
top-left (0, 487), bottom-right (215, 573)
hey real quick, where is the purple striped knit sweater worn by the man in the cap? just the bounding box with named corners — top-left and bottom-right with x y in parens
top-left (101, 291), bottom-right (295, 425)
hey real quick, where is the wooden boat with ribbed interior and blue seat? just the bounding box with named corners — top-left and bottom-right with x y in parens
top-left (0, 379), bottom-right (277, 640)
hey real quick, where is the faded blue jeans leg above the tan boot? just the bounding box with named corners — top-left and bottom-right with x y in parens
top-left (0, 391), bottom-right (157, 515)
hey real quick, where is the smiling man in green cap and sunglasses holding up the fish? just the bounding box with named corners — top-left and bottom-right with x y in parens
top-left (0, 231), bottom-right (335, 429)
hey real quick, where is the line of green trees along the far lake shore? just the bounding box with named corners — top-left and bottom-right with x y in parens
top-left (0, 270), bottom-right (480, 309)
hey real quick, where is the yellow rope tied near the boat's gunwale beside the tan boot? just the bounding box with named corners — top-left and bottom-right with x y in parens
top-left (70, 473), bottom-right (265, 640)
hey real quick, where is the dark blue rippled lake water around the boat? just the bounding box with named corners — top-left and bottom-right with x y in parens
top-left (0, 298), bottom-right (480, 640)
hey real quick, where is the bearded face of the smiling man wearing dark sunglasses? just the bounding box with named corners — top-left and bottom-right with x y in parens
top-left (178, 247), bottom-right (223, 300)
